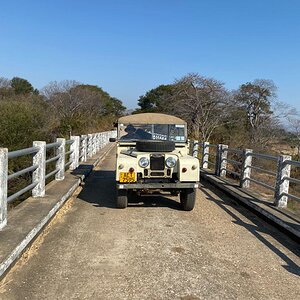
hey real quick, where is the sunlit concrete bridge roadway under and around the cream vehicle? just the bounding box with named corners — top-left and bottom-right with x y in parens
top-left (0, 150), bottom-right (300, 300)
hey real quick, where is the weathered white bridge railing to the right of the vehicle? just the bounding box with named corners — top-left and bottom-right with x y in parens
top-left (191, 141), bottom-right (300, 208)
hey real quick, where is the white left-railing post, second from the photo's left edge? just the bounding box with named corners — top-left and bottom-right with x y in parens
top-left (32, 141), bottom-right (46, 197)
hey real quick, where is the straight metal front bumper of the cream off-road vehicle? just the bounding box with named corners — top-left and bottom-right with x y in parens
top-left (117, 182), bottom-right (199, 190)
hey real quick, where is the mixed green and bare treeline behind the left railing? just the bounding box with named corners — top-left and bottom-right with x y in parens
top-left (0, 77), bottom-right (125, 150)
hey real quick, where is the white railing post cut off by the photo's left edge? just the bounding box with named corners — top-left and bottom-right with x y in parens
top-left (0, 148), bottom-right (8, 230)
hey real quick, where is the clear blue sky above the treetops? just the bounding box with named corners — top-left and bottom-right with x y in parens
top-left (0, 0), bottom-right (300, 110)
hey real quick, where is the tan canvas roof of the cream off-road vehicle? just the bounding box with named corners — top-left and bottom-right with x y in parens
top-left (118, 113), bottom-right (186, 125)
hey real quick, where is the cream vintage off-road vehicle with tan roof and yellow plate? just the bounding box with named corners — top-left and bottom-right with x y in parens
top-left (112, 113), bottom-right (199, 211)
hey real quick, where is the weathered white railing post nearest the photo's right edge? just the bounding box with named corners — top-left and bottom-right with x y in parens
top-left (274, 155), bottom-right (292, 208)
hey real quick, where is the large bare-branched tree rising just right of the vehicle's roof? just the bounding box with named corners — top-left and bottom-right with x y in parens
top-left (169, 73), bottom-right (230, 141)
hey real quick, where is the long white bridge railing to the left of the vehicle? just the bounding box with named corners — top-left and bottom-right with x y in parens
top-left (0, 131), bottom-right (116, 230)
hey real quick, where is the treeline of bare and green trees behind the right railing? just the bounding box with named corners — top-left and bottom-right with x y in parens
top-left (134, 73), bottom-right (297, 152)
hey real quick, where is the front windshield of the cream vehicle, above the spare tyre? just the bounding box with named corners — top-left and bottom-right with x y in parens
top-left (118, 124), bottom-right (186, 143)
